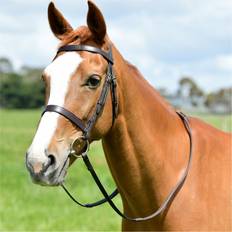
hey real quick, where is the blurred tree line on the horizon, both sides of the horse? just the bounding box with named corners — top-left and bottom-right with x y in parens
top-left (0, 58), bottom-right (232, 113)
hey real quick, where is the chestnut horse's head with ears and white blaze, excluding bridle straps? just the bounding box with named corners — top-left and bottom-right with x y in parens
top-left (26, 1), bottom-right (117, 185)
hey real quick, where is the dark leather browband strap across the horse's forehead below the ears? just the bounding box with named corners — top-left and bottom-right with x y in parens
top-left (57, 45), bottom-right (114, 64)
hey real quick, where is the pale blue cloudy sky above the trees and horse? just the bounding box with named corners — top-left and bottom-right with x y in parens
top-left (0, 0), bottom-right (232, 92)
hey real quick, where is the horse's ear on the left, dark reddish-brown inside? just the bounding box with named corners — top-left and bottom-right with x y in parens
top-left (48, 2), bottom-right (73, 39)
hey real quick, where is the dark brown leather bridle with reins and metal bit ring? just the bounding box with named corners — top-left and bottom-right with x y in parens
top-left (42, 45), bottom-right (192, 222)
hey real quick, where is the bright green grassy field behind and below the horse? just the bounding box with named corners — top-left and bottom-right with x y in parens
top-left (0, 110), bottom-right (231, 231)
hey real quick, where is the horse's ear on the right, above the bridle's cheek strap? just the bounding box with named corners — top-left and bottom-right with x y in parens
top-left (87, 1), bottom-right (106, 44)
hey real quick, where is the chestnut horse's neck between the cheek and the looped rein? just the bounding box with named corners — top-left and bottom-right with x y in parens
top-left (103, 49), bottom-right (189, 216)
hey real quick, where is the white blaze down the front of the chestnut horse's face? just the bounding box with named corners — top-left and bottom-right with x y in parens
top-left (29, 52), bottom-right (82, 162)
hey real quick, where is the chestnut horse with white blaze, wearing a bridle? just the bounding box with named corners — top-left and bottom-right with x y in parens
top-left (26, 1), bottom-right (232, 231)
